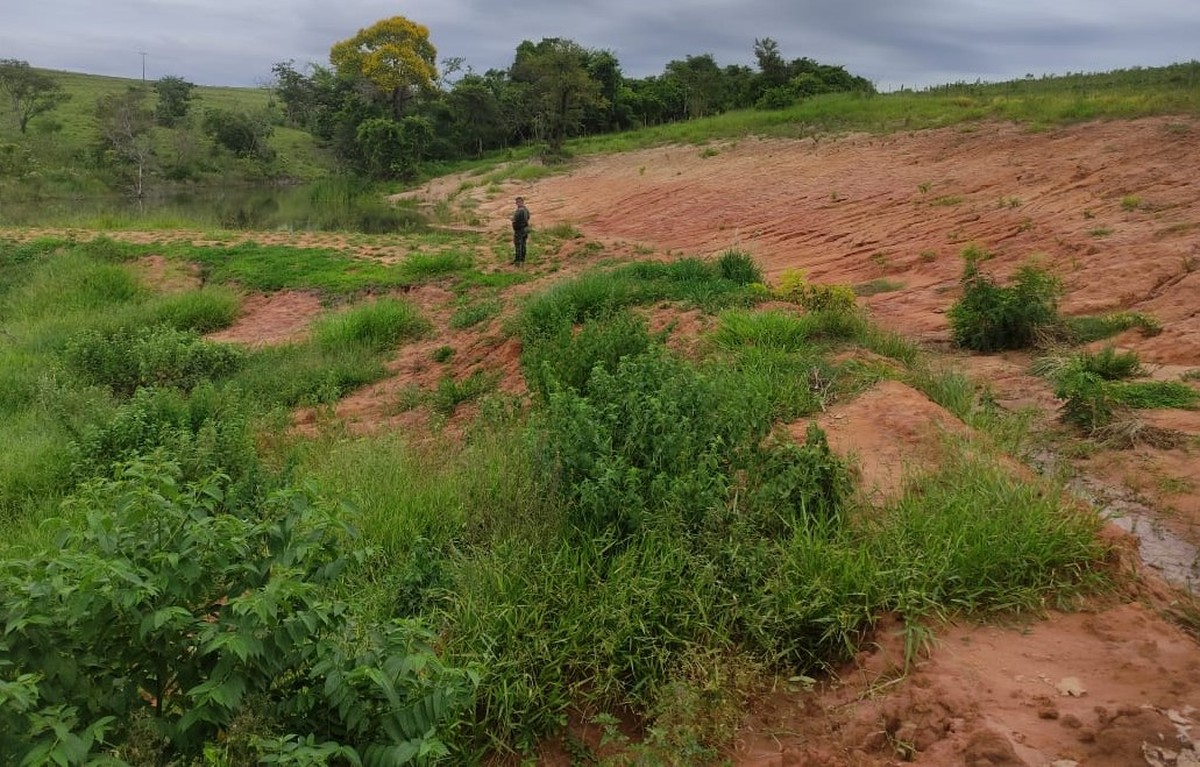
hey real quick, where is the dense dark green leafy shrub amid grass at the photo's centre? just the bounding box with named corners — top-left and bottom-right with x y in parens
top-left (542, 350), bottom-right (787, 538)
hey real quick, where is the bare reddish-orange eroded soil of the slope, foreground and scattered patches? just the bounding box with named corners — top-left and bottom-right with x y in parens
top-left (11, 118), bottom-right (1200, 767)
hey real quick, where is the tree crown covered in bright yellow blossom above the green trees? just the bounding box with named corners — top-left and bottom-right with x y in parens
top-left (329, 16), bottom-right (438, 120)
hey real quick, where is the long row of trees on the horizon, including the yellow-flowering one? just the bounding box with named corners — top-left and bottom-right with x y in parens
top-left (272, 17), bottom-right (875, 178)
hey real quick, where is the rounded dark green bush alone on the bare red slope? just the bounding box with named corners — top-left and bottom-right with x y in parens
top-left (947, 252), bottom-right (1062, 352)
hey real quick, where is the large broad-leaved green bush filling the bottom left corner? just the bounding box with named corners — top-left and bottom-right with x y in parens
top-left (0, 461), bottom-right (473, 766)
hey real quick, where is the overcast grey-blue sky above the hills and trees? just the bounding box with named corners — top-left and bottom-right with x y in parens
top-left (0, 0), bottom-right (1200, 90)
